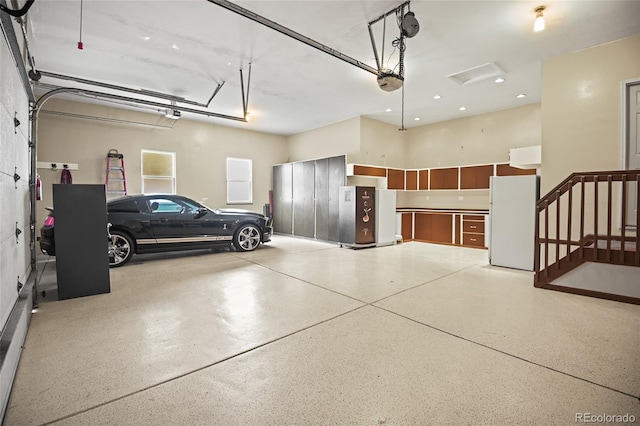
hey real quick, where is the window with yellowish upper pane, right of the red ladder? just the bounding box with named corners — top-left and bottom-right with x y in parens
top-left (141, 149), bottom-right (176, 194)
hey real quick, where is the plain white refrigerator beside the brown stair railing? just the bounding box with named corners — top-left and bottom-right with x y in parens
top-left (489, 175), bottom-right (540, 271)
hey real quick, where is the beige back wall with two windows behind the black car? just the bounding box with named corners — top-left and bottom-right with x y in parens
top-left (37, 100), bottom-right (288, 223)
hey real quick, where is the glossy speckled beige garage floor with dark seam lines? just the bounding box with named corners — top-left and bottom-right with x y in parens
top-left (5, 236), bottom-right (640, 425)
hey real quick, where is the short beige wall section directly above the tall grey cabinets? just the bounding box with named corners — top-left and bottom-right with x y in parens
top-left (284, 117), bottom-right (360, 162)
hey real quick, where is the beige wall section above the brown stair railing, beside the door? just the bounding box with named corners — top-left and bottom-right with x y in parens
top-left (542, 34), bottom-right (640, 193)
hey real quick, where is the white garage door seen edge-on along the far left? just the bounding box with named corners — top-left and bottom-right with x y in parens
top-left (0, 22), bottom-right (31, 417)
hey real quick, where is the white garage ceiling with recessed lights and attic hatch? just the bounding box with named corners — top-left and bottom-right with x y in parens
top-left (29, 0), bottom-right (640, 135)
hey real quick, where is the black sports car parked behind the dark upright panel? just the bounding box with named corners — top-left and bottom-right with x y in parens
top-left (40, 195), bottom-right (273, 267)
